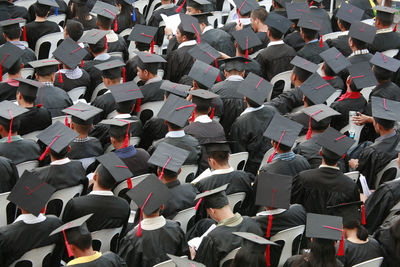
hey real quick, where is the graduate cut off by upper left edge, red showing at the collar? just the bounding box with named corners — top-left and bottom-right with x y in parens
top-left (0, 42), bottom-right (24, 101)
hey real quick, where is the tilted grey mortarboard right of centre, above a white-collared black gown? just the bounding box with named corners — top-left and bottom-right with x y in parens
top-left (238, 72), bottom-right (273, 105)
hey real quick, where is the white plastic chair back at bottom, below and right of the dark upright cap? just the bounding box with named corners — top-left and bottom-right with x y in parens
top-left (270, 225), bottom-right (305, 266)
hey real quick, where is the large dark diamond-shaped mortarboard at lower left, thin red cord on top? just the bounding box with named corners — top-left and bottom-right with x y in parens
top-left (4, 171), bottom-right (56, 217)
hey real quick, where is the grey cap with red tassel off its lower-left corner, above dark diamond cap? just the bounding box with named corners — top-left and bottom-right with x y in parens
top-left (37, 121), bottom-right (79, 161)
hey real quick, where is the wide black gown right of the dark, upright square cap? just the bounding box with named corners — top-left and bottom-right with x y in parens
top-left (290, 167), bottom-right (360, 214)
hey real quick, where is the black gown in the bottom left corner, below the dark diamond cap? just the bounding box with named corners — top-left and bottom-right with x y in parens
top-left (0, 215), bottom-right (63, 267)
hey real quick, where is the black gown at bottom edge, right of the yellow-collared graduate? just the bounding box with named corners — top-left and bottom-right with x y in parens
top-left (118, 220), bottom-right (189, 267)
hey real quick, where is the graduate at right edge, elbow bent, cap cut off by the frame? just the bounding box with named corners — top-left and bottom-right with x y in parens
top-left (349, 97), bottom-right (400, 189)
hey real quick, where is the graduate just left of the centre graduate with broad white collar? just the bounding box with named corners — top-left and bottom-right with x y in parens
top-left (149, 143), bottom-right (197, 219)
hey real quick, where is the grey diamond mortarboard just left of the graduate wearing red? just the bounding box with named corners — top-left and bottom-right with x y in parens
top-left (300, 73), bottom-right (336, 104)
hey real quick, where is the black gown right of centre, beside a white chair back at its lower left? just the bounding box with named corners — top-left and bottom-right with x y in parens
top-left (228, 106), bottom-right (276, 174)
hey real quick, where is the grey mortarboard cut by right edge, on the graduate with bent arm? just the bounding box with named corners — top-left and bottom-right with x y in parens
top-left (371, 96), bottom-right (400, 121)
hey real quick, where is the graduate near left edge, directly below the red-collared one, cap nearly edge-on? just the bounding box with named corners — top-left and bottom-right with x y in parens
top-left (17, 78), bottom-right (51, 135)
